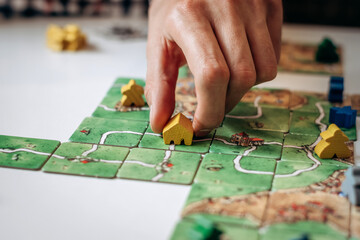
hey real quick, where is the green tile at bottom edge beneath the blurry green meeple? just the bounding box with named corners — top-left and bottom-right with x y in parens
top-left (170, 220), bottom-right (258, 240)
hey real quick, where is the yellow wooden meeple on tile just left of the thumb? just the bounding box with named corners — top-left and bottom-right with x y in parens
top-left (121, 79), bottom-right (145, 107)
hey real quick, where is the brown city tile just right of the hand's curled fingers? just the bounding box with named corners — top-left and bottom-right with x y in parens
top-left (239, 88), bottom-right (291, 109)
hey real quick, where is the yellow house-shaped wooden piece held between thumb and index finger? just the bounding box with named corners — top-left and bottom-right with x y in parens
top-left (163, 113), bottom-right (194, 145)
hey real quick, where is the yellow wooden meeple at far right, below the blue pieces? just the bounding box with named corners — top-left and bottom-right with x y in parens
top-left (314, 124), bottom-right (351, 159)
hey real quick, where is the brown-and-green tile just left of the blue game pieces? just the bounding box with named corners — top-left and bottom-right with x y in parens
top-left (289, 91), bottom-right (332, 113)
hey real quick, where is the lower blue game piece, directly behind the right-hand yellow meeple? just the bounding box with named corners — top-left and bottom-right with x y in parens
top-left (329, 106), bottom-right (357, 128)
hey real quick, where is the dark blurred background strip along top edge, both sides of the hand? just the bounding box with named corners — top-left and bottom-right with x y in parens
top-left (0, 0), bottom-right (360, 27)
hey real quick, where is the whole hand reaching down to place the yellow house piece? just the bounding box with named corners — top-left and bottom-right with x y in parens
top-left (145, 0), bottom-right (282, 136)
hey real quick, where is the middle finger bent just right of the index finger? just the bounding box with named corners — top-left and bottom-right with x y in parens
top-left (210, 2), bottom-right (256, 112)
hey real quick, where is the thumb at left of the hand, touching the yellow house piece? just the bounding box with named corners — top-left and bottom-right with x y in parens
top-left (145, 35), bottom-right (180, 133)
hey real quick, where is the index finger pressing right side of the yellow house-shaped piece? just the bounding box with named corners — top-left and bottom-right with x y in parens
top-left (170, 1), bottom-right (229, 136)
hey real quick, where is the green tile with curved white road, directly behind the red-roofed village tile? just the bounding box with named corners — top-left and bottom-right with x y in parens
top-left (225, 104), bottom-right (290, 132)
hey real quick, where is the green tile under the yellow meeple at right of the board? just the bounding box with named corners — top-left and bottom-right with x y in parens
top-left (281, 134), bottom-right (356, 165)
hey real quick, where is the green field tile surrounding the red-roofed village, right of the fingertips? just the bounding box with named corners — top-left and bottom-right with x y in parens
top-left (210, 119), bottom-right (283, 159)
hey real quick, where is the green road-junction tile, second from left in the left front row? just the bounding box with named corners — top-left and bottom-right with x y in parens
top-left (43, 142), bottom-right (129, 178)
